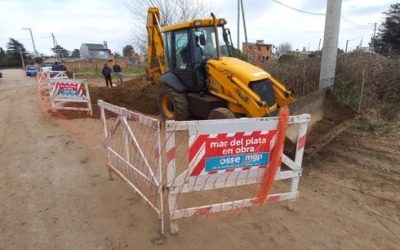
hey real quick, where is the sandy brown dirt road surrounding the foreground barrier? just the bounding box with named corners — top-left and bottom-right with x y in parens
top-left (0, 70), bottom-right (400, 249)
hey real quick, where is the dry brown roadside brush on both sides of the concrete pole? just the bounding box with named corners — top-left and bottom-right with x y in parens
top-left (260, 52), bottom-right (400, 136)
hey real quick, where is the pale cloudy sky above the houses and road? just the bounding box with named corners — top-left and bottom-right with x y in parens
top-left (0, 0), bottom-right (396, 55)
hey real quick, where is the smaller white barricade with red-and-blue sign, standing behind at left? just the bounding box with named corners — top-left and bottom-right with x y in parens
top-left (49, 78), bottom-right (93, 115)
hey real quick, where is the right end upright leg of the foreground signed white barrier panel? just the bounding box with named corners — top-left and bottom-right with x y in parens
top-left (288, 123), bottom-right (308, 211)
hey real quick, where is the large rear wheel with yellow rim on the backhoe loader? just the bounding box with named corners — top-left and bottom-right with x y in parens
top-left (158, 87), bottom-right (190, 121)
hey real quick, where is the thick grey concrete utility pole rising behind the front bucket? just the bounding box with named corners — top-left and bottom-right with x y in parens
top-left (319, 0), bottom-right (342, 89)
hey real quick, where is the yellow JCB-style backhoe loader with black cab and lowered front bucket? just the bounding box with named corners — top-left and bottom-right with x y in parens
top-left (146, 7), bottom-right (355, 156)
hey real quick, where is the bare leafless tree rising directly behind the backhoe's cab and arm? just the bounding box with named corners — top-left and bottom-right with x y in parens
top-left (128, 0), bottom-right (210, 54)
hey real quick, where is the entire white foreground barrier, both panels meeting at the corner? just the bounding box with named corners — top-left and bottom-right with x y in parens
top-left (98, 101), bottom-right (310, 233)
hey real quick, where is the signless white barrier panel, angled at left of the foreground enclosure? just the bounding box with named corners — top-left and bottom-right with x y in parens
top-left (97, 100), bottom-right (164, 234)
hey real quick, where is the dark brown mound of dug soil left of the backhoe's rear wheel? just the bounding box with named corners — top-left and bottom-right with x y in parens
top-left (89, 77), bottom-right (159, 115)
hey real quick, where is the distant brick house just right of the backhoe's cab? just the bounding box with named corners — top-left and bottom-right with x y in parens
top-left (242, 40), bottom-right (272, 62)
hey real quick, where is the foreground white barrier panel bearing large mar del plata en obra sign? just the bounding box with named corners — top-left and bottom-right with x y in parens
top-left (166, 114), bottom-right (310, 233)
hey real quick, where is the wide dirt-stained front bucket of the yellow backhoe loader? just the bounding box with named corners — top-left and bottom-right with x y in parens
top-left (286, 89), bottom-right (357, 157)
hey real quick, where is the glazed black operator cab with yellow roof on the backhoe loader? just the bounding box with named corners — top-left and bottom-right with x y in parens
top-left (161, 19), bottom-right (230, 92)
